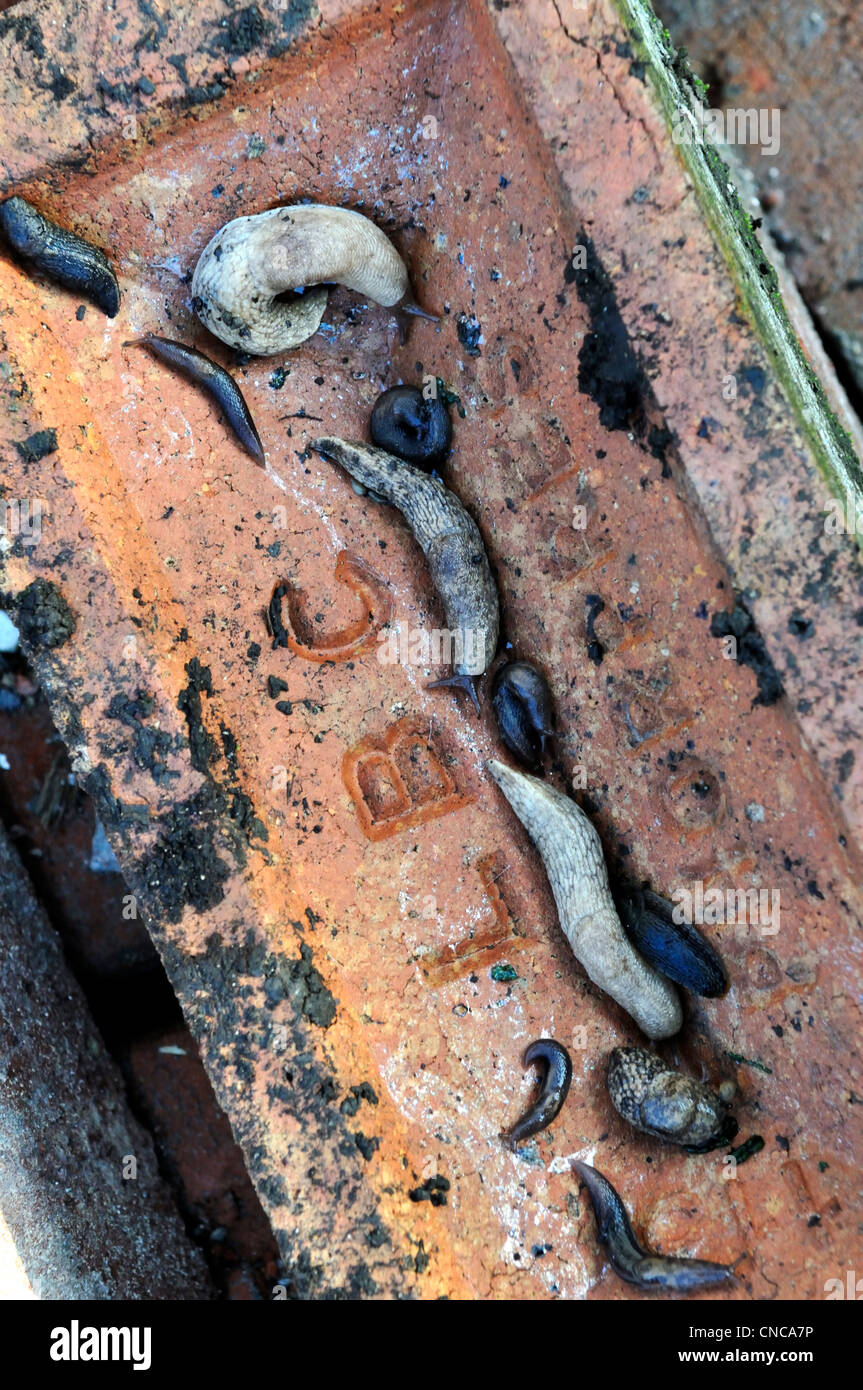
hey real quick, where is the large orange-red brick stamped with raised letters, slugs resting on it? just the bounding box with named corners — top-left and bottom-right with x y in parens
top-left (0, 3), bottom-right (863, 1298)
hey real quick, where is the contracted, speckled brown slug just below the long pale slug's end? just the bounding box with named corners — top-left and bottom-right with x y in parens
top-left (606, 1047), bottom-right (738, 1154)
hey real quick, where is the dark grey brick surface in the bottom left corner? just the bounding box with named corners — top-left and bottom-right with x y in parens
top-left (0, 827), bottom-right (211, 1298)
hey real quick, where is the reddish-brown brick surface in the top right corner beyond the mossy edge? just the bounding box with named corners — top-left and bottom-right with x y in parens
top-left (656, 0), bottom-right (863, 395)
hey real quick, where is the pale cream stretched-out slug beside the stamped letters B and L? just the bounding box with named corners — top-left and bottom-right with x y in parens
top-left (488, 762), bottom-right (682, 1038)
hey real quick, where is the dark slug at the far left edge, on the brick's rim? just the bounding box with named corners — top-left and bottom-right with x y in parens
top-left (0, 197), bottom-right (120, 318)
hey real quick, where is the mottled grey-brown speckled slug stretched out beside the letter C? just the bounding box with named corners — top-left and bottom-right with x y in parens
top-left (311, 436), bottom-right (499, 713)
